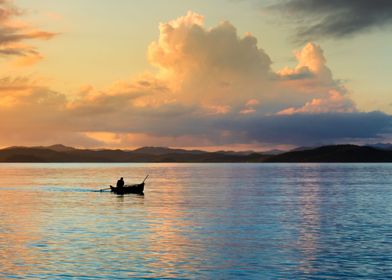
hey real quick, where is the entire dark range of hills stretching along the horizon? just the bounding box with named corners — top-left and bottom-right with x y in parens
top-left (0, 144), bottom-right (392, 162)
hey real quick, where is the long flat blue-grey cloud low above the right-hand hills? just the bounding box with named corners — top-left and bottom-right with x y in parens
top-left (221, 112), bottom-right (392, 145)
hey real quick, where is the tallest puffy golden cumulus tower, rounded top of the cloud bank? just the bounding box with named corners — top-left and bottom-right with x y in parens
top-left (148, 12), bottom-right (271, 107)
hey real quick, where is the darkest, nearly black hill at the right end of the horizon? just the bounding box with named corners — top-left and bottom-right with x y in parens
top-left (264, 145), bottom-right (392, 162)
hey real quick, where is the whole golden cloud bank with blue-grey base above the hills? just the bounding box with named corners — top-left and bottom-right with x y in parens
top-left (0, 12), bottom-right (391, 150)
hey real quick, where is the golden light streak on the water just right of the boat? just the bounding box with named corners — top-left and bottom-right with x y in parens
top-left (142, 170), bottom-right (203, 277)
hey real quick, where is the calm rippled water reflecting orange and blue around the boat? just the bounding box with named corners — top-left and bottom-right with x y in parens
top-left (0, 164), bottom-right (392, 279)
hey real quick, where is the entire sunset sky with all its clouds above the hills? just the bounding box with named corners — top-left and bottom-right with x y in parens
top-left (0, 0), bottom-right (392, 151)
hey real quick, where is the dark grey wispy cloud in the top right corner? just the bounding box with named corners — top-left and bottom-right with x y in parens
top-left (271, 0), bottom-right (392, 41)
